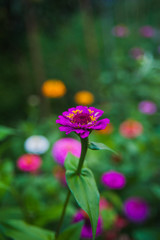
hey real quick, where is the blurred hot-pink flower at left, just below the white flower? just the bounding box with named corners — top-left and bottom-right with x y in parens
top-left (17, 154), bottom-right (42, 172)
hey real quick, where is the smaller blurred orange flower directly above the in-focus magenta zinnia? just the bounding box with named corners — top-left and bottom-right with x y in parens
top-left (74, 91), bottom-right (94, 105)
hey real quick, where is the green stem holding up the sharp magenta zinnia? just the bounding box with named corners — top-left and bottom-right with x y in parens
top-left (55, 138), bottom-right (88, 239)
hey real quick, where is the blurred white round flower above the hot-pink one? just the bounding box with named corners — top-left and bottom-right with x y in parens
top-left (24, 135), bottom-right (49, 154)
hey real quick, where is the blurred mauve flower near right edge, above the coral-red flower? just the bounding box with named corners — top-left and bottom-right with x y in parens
top-left (138, 101), bottom-right (157, 115)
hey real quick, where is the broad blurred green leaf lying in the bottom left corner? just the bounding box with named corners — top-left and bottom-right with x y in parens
top-left (4, 220), bottom-right (54, 240)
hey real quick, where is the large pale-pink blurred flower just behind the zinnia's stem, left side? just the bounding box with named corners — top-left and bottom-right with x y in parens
top-left (52, 138), bottom-right (81, 166)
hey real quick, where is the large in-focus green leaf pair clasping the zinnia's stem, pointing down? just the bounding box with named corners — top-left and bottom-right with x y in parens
top-left (65, 155), bottom-right (99, 239)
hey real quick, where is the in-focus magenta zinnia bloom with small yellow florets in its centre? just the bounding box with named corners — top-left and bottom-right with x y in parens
top-left (56, 106), bottom-right (110, 138)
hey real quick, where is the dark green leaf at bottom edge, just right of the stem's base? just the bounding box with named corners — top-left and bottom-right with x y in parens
top-left (57, 221), bottom-right (84, 240)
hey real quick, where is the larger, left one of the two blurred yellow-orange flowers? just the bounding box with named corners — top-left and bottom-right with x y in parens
top-left (42, 79), bottom-right (66, 98)
